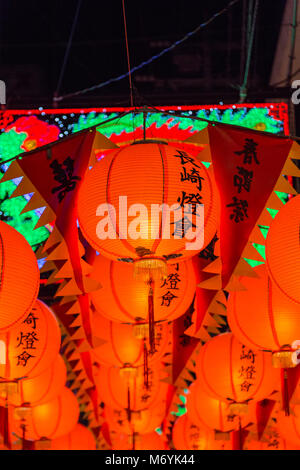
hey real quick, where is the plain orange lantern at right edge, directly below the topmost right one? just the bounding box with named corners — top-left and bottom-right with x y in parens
top-left (227, 265), bottom-right (300, 351)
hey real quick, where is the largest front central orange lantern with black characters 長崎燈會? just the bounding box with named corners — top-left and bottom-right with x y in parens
top-left (78, 143), bottom-right (219, 260)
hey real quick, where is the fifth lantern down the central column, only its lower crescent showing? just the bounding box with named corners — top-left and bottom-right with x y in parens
top-left (104, 402), bottom-right (166, 435)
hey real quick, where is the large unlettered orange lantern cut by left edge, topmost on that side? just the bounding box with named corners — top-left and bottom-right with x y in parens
top-left (0, 221), bottom-right (40, 332)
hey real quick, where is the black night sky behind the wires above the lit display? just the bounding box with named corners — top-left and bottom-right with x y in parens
top-left (0, 0), bottom-right (290, 108)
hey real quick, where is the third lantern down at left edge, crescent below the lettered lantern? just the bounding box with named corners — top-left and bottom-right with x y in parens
top-left (0, 356), bottom-right (67, 406)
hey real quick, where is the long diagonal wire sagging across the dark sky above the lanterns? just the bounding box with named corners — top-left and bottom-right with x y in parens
top-left (54, 0), bottom-right (240, 101)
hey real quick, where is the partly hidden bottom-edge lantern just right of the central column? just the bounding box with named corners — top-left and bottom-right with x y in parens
top-left (172, 413), bottom-right (231, 450)
